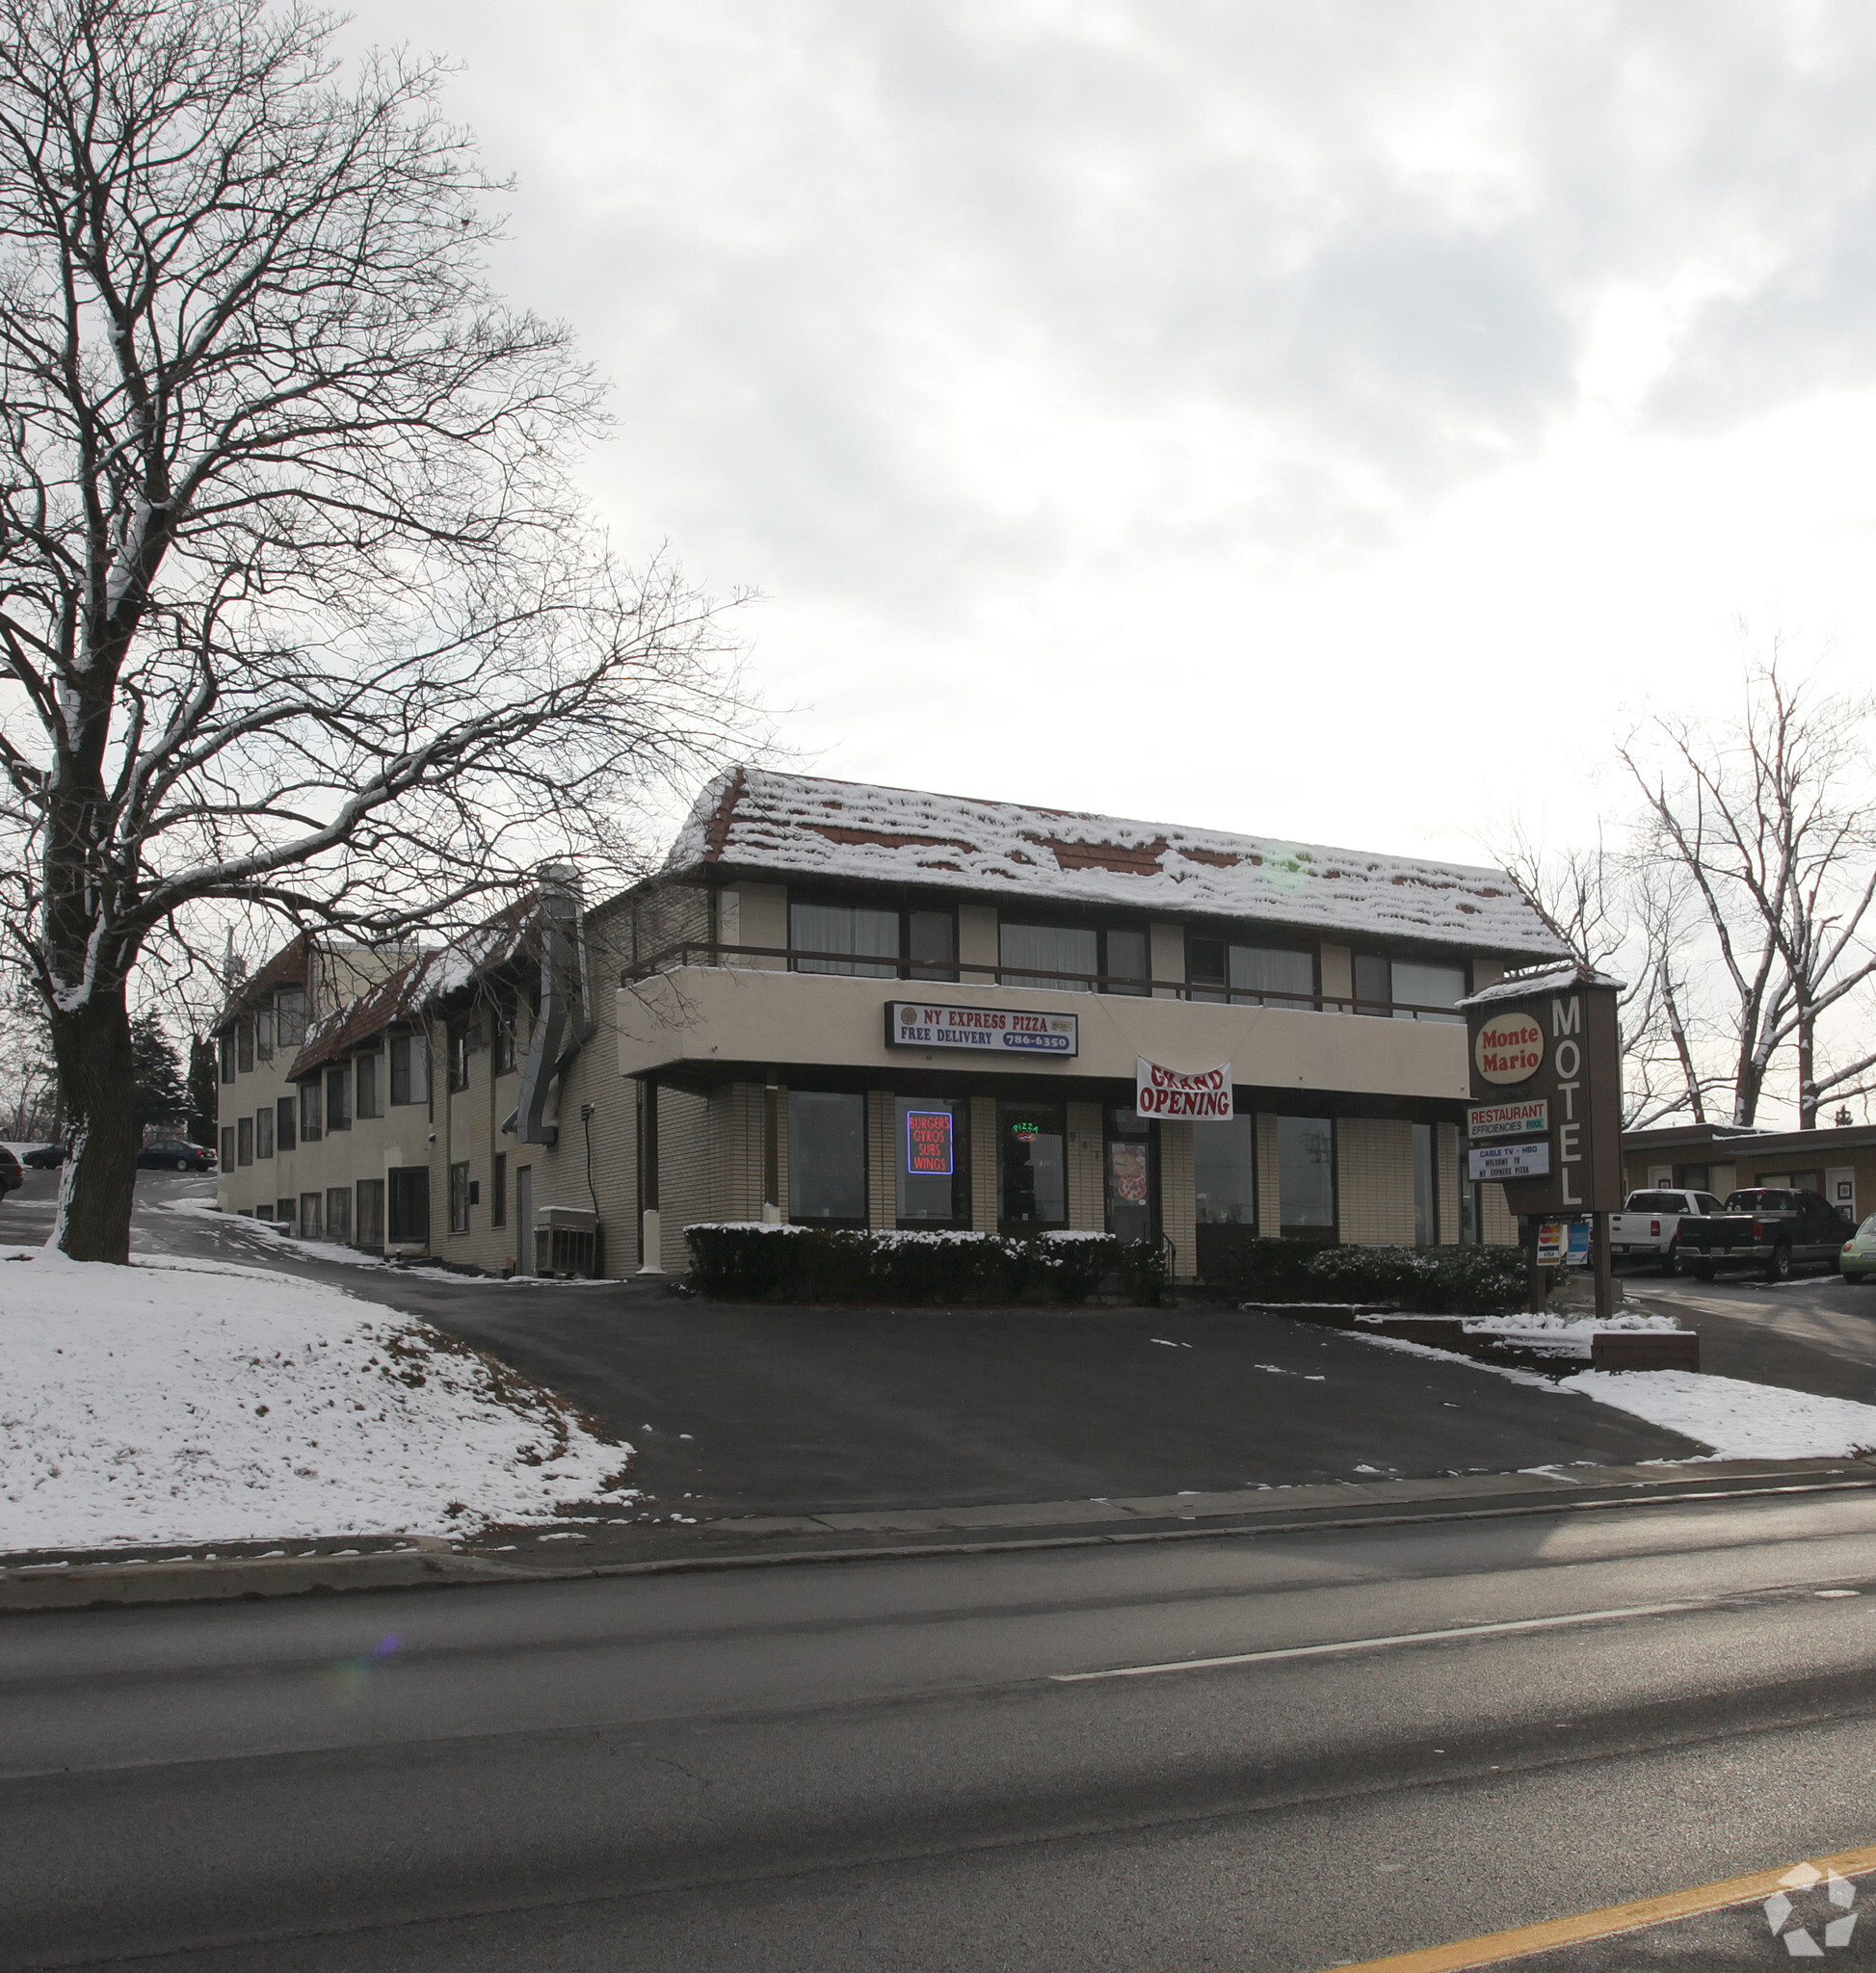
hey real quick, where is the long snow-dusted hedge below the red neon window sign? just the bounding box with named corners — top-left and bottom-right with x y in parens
top-left (684, 1222), bottom-right (1166, 1304)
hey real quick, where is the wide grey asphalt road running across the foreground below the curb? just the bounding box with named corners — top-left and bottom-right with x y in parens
top-left (0, 1493), bottom-right (1876, 1973)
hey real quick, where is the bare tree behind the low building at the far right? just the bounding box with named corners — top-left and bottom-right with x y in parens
top-left (1620, 649), bottom-right (1876, 1131)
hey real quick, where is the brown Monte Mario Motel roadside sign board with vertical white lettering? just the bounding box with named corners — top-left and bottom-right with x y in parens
top-left (1460, 967), bottom-right (1622, 1216)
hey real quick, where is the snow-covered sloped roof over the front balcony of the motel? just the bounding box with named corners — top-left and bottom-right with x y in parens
top-left (665, 768), bottom-right (1565, 959)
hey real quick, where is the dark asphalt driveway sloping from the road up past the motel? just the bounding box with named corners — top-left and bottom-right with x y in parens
top-left (0, 1172), bottom-right (1701, 1515)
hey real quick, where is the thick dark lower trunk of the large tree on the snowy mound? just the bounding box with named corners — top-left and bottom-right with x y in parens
top-left (51, 986), bottom-right (140, 1267)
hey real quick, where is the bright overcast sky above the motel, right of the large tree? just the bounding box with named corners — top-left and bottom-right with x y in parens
top-left (351, 0), bottom-right (1876, 860)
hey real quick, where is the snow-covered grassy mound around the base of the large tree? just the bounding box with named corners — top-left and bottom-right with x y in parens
top-left (0, 1250), bottom-right (631, 1551)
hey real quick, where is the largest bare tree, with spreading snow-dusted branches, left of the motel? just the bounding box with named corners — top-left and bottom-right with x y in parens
top-left (0, 0), bottom-right (736, 1261)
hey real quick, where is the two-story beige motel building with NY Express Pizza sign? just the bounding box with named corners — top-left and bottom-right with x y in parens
top-left (221, 770), bottom-right (1562, 1278)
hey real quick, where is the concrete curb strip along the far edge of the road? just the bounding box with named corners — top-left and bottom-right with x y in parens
top-left (14, 1460), bottom-right (1876, 1614)
